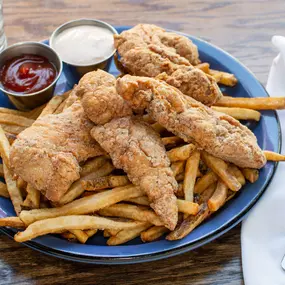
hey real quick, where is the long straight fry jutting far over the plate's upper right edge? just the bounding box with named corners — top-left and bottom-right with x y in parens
top-left (214, 96), bottom-right (285, 110)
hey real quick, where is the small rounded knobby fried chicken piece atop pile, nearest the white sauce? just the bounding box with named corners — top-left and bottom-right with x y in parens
top-left (76, 69), bottom-right (132, 125)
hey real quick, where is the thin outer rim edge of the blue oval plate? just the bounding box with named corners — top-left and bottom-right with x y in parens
top-left (0, 26), bottom-right (282, 264)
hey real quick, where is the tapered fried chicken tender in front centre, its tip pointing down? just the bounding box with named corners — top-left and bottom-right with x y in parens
top-left (91, 117), bottom-right (178, 230)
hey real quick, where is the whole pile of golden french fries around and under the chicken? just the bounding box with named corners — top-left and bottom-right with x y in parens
top-left (0, 63), bottom-right (285, 245)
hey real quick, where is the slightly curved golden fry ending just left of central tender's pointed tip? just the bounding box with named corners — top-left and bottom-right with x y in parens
top-left (99, 204), bottom-right (163, 226)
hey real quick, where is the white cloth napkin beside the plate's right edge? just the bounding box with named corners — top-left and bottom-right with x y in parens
top-left (241, 36), bottom-right (285, 285)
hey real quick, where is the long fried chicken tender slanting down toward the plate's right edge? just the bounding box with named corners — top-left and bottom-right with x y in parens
top-left (116, 75), bottom-right (266, 168)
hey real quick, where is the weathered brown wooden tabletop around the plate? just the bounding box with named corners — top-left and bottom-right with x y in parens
top-left (0, 0), bottom-right (285, 285)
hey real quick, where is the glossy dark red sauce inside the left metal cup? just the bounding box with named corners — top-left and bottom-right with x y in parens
top-left (0, 54), bottom-right (57, 94)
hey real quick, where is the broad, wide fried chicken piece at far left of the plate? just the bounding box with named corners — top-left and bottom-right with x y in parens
top-left (10, 101), bottom-right (105, 202)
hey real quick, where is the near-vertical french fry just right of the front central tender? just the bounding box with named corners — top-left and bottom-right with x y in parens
top-left (183, 151), bottom-right (200, 202)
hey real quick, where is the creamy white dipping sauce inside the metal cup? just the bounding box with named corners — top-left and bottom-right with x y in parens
top-left (54, 25), bottom-right (114, 65)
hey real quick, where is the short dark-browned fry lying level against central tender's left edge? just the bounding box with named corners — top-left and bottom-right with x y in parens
top-left (81, 175), bottom-right (130, 191)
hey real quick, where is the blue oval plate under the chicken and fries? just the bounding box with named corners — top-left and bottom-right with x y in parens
top-left (0, 27), bottom-right (281, 264)
